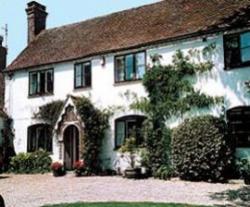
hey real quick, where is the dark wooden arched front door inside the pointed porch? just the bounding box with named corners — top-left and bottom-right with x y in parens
top-left (64, 125), bottom-right (79, 170)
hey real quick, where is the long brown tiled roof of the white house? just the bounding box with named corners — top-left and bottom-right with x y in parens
top-left (7, 0), bottom-right (250, 70)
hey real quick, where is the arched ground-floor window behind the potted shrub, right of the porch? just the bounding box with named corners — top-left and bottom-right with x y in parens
top-left (115, 116), bottom-right (146, 148)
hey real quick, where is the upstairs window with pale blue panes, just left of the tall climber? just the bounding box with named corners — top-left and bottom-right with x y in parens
top-left (115, 52), bottom-right (146, 83)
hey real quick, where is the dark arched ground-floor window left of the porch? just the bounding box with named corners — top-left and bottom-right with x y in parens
top-left (27, 124), bottom-right (52, 152)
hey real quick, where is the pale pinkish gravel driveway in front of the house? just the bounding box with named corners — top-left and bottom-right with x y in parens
top-left (0, 174), bottom-right (247, 207)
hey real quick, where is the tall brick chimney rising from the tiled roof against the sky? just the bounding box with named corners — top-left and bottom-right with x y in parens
top-left (26, 1), bottom-right (48, 44)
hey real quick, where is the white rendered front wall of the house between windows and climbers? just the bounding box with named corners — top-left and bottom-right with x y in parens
top-left (5, 32), bottom-right (250, 166)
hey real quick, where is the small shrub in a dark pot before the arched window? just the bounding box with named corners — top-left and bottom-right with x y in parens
top-left (120, 137), bottom-right (141, 178)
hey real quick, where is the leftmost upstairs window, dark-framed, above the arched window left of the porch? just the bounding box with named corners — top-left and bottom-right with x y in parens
top-left (29, 69), bottom-right (54, 96)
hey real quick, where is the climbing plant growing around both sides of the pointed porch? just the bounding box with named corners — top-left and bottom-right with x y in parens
top-left (34, 96), bottom-right (111, 174)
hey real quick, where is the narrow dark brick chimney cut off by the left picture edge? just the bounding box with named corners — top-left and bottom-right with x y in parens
top-left (0, 36), bottom-right (7, 109)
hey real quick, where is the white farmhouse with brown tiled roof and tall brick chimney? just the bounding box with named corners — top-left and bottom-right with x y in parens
top-left (5, 0), bottom-right (250, 169)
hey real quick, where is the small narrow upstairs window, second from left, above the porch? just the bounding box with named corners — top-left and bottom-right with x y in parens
top-left (74, 62), bottom-right (91, 89)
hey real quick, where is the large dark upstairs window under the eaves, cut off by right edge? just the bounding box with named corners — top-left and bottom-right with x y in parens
top-left (224, 32), bottom-right (250, 70)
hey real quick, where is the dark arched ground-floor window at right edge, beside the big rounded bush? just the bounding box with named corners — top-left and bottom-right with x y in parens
top-left (227, 106), bottom-right (250, 148)
